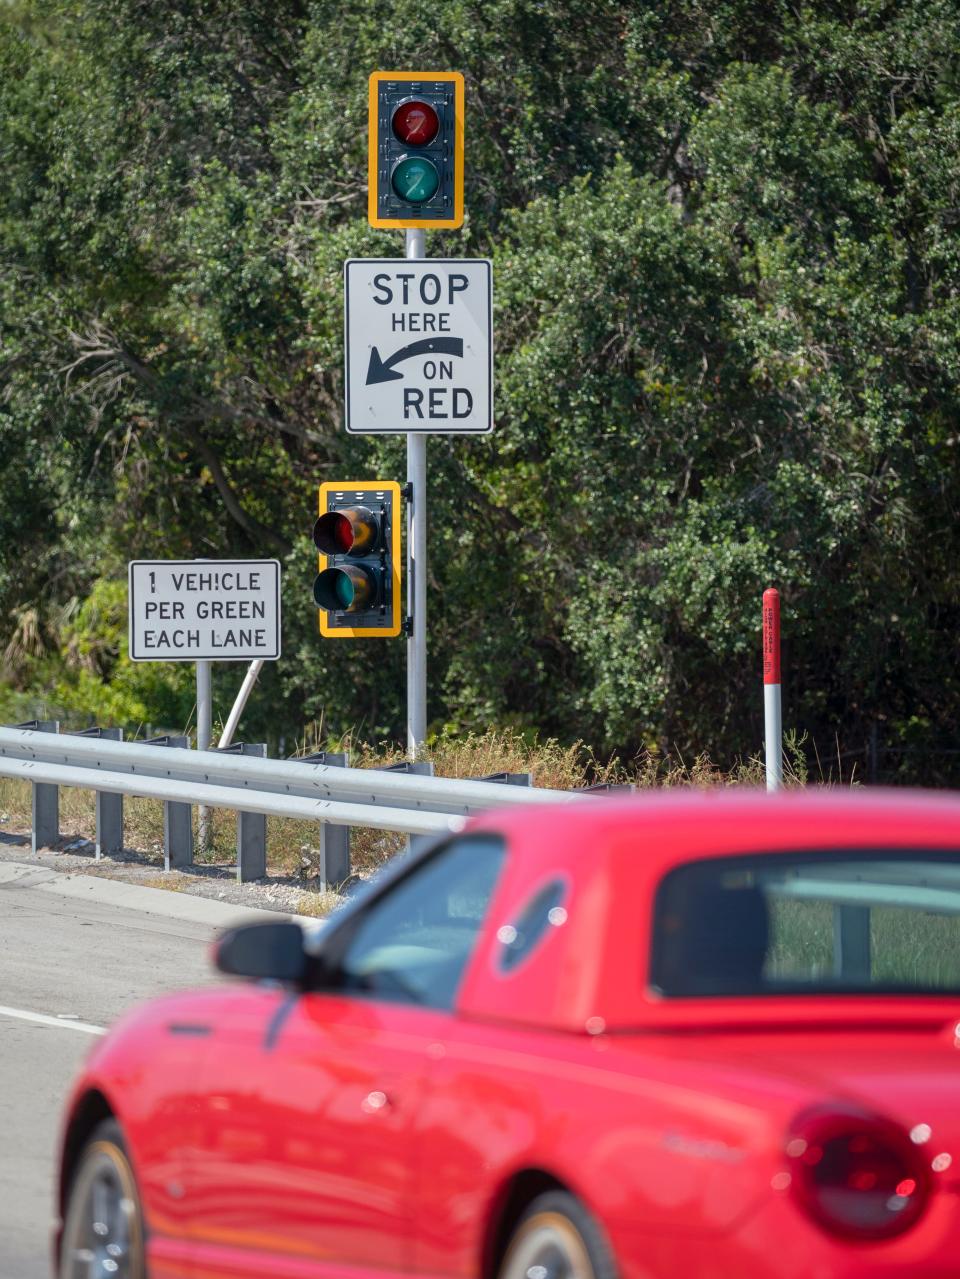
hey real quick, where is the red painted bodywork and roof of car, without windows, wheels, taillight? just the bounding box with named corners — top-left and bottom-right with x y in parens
top-left (56, 792), bottom-right (960, 1279)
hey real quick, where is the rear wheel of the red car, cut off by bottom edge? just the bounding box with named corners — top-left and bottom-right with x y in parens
top-left (499, 1191), bottom-right (616, 1279)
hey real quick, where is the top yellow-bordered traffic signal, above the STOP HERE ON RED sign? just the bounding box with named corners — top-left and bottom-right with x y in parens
top-left (367, 72), bottom-right (464, 229)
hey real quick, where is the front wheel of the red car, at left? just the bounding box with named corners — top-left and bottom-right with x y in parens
top-left (60, 1119), bottom-right (147, 1279)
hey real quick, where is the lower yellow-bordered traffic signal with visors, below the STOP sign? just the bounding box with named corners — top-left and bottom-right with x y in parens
top-left (313, 480), bottom-right (401, 638)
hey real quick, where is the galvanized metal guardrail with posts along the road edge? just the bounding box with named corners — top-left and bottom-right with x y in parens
top-left (0, 721), bottom-right (580, 886)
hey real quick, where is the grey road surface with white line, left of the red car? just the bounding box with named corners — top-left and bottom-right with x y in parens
top-left (0, 863), bottom-right (277, 1279)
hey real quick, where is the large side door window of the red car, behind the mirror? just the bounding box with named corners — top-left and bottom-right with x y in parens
top-left (337, 834), bottom-right (506, 1009)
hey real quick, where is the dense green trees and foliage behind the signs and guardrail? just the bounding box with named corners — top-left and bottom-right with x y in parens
top-left (0, 0), bottom-right (960, 779)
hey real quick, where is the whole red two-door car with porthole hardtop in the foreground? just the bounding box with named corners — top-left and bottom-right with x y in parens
top-left (58, 793), bottom-right (960, 1279)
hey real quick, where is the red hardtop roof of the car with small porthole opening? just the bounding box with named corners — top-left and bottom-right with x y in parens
top-left (458, 788), bottom-right (960, 1031)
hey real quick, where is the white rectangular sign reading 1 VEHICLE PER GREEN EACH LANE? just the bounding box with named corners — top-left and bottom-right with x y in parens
top-left (128, 560), bottom-right (280, 661)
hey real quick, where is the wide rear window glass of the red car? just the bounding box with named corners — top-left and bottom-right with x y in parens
top-left (651, 849), bottom-right (960, 996)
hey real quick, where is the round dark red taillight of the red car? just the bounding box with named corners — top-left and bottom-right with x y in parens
top-left (785, 1108), bottom-right (931, 1239)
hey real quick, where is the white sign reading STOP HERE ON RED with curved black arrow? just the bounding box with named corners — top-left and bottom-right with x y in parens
top-left (344, 257), bottom-right (493, 435)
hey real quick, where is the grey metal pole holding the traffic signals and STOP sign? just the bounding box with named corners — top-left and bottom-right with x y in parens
top-left (405, 228), bottom-right (427, 760)
